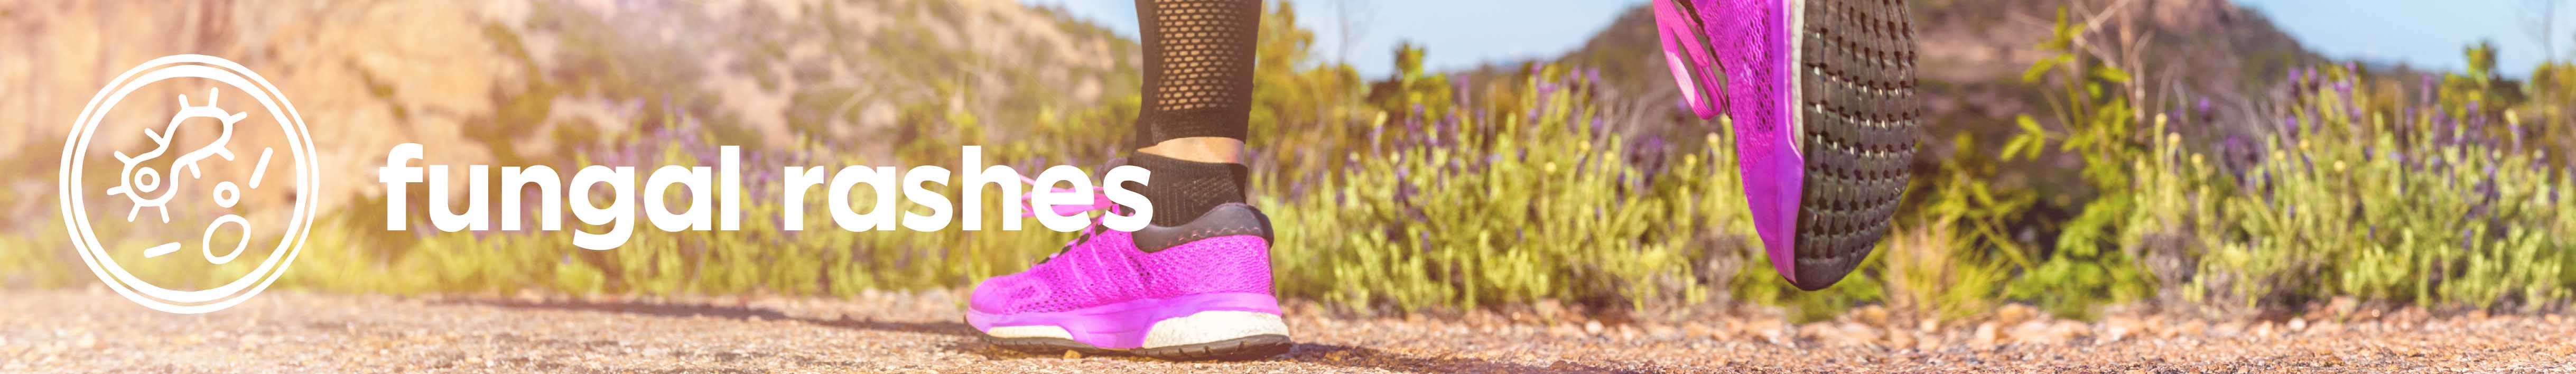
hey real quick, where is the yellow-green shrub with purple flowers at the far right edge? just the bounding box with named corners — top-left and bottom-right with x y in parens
top-left (2131, 67), bottom-right (2576, 310)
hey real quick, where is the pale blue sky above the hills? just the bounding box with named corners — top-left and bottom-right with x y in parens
top-left (1020, 0), bottom-right (2576, 77)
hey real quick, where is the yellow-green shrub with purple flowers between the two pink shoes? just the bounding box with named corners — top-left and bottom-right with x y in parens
top-left (1262, 67), bottom-right (1767, 310)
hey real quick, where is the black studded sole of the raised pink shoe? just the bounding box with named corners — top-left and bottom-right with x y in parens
top-left (1793, 0), bottom-right (1922, 292)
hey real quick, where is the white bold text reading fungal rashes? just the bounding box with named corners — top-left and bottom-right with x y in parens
top-left (376, 142), bottom-right (1154, 250)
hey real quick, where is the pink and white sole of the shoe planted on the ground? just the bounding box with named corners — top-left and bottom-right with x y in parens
top-left (966, 294), bottom-right (1296, 361)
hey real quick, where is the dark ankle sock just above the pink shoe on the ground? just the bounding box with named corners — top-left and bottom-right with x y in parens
top-left (1126, 152), bottom-right (1252, 227)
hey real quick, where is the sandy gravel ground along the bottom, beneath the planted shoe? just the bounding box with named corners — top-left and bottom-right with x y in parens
top-left (0, 289), bottom-right (2576, 371)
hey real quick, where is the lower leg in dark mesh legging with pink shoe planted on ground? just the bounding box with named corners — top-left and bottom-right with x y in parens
top-left (966, 0), bottom-right (1293, 359)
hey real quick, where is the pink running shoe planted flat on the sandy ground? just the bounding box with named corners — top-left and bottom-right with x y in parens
top-left (966, 179), bottom-right (1293, 361)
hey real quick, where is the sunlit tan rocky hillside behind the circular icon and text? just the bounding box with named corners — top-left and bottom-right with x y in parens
top-left (0, 0), bottom-right (1136, 230)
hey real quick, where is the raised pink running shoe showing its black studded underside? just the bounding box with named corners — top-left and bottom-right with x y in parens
top-left (1654, 0), bottom-right (1922, 292)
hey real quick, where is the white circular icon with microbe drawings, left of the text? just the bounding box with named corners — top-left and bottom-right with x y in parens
top-left (59, 54), bottom-right (320, 315)
